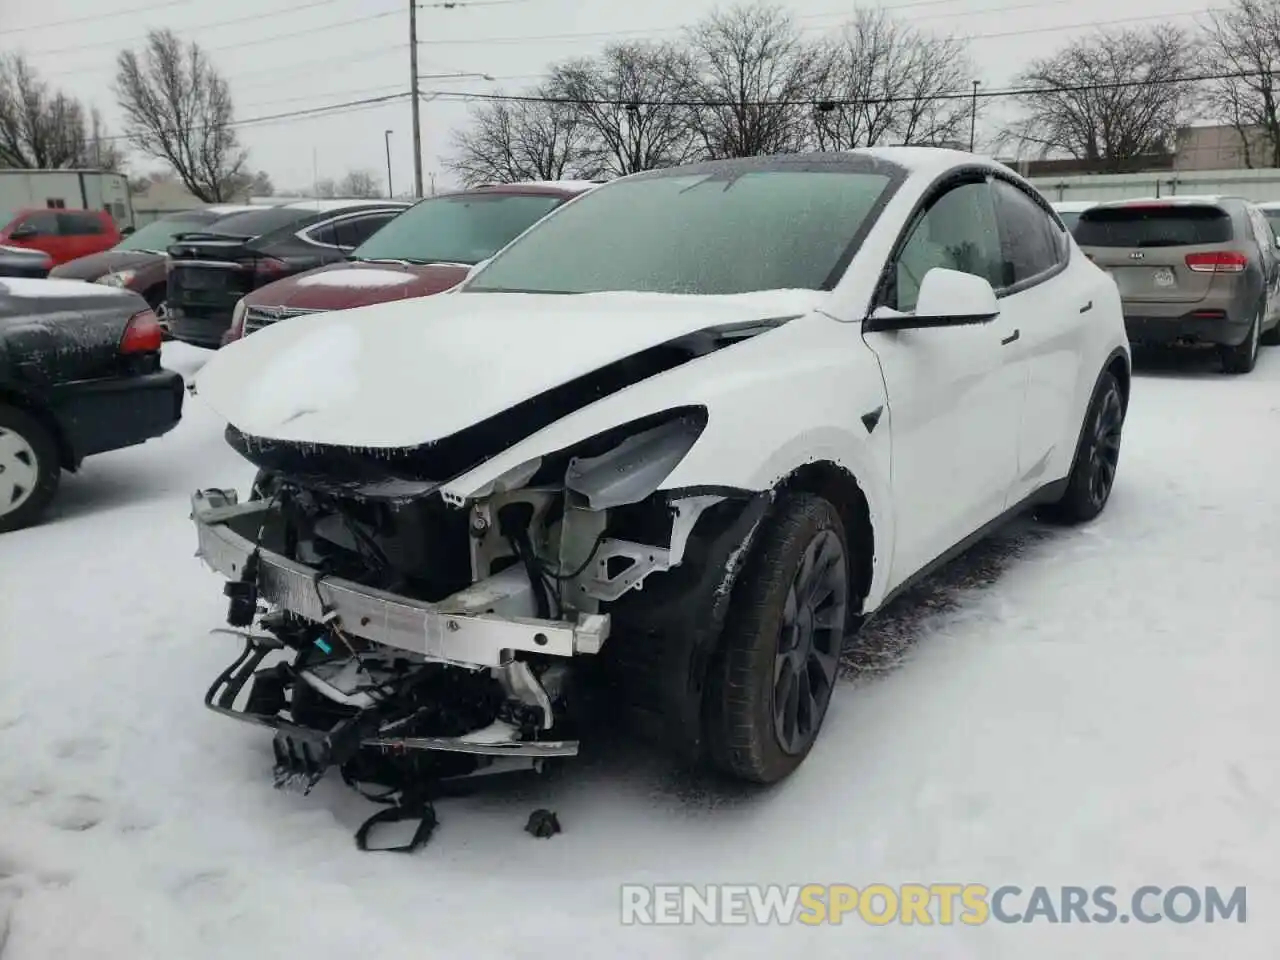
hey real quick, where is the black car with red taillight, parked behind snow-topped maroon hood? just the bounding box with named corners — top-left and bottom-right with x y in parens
top-left (166, 200), bottom-right (408, 348)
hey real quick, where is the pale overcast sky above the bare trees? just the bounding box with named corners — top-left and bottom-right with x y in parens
top-left (0, 0), bottom-right (1206, 192)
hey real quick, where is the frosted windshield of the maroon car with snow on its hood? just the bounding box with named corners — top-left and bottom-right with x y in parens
top-left (352, 193), bottom-right (563, 266)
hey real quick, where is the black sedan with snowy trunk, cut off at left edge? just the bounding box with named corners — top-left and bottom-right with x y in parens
top-left (0, 279), bottom-right (184, 532)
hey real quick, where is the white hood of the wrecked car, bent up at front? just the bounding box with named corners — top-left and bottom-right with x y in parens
top-left (196, 291), bottom-right (827, 449)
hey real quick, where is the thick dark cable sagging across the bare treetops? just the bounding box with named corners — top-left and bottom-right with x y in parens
top-left (430, 70), bottom-right (1268, 110)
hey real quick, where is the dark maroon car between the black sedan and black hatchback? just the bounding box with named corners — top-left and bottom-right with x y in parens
top-left (49, 204), bottom-right (261, 319)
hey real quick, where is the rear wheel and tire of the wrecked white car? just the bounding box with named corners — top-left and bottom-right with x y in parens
top-left (1041, 372), bottom-right (1125, 524)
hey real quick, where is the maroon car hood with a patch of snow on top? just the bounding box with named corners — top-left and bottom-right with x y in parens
top-left (244, 264), bottom-right (467, 310)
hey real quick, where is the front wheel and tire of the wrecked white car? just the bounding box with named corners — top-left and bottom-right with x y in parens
top-left (705, 494), bottom-right (854, 783)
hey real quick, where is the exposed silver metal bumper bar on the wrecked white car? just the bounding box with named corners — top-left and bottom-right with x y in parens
top-left (191, 490), bottom-right (609, 670)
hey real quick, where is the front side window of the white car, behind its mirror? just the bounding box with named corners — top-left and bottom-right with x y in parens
top-left (890, 182), bottom-right (1004, 312)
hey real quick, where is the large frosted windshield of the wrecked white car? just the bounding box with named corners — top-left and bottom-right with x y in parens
top-left (465, 169), bottom-right (892, 294)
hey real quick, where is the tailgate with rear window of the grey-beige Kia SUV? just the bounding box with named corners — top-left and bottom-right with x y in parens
top-left (1075, 201), bottom-right (1236, 308)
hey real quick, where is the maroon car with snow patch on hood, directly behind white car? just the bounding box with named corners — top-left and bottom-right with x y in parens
top-left (223, 180), bottom-right (595, 343)
